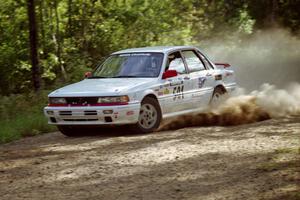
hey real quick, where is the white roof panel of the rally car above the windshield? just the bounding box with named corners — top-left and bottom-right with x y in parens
top-left (112, 46), bottom-right (195, 54)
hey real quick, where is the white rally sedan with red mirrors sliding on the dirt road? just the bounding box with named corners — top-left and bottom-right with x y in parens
top-left (44, 46), bottom-right (236, 136)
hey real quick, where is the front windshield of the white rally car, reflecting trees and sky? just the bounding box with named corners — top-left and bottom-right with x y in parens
top-left (90, 53), bottom-right (164, 78)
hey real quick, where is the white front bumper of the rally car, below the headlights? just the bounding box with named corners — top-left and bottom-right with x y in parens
top-left (44, 103), bottom-right (140, 125)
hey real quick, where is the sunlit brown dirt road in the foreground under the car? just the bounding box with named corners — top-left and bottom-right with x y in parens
top-left (0, 117), bottom-right (300, 200)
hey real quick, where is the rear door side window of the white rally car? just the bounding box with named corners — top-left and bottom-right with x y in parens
top-left (182, 51), bottom-right (205, 72)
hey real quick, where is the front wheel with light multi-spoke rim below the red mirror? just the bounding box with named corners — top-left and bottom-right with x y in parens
top-left (131, 97), bottom-right (162, 133)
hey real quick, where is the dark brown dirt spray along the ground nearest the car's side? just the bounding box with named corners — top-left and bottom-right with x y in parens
top-left (159, 95), bottom-right (271, 131)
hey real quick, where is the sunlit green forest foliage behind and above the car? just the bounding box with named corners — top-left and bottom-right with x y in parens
top-left (0, 0), bottom-right (300, 95)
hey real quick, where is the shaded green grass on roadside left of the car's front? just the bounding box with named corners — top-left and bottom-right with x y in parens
top-left (0, 91), bottom-right (56, 143)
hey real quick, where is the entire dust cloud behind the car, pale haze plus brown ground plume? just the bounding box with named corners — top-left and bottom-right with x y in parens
top-left (160, 29), bottom-right (300, 130)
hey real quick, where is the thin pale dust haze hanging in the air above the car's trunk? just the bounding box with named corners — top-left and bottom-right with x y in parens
top-left (200, 29), bottom-right (300, 91)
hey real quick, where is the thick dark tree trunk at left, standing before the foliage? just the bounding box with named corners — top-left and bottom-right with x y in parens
top-left (27, 0), bottom-right (41, 92)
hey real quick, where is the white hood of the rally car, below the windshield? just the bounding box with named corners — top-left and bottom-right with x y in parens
top-left (49, 78), bottom-right (157, 97)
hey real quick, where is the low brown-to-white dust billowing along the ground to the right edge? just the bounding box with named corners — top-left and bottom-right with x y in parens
top-left (159, 83), bottom-right (300, 130)
